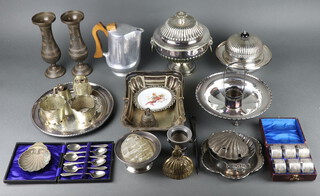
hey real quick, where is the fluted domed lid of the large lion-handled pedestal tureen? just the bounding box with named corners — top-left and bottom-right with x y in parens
top-left (160, 11), bottom-right (204, 43)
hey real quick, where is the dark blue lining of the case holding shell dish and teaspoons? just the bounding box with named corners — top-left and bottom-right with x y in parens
top-left (5, 142), bottom-right (113, 182)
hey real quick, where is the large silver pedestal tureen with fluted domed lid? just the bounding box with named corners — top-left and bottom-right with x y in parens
top-left (151, 11), bottom-right (212, 76)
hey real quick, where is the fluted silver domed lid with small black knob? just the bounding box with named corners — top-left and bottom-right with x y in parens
top-left (225, 31), bottom-right (263, 60)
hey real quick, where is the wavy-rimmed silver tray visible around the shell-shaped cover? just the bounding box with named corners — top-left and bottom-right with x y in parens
top-left (201, 137), bottom-right (264, 179)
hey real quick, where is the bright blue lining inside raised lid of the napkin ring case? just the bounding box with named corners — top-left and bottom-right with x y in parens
top-left (261, 118), bottom-right (305, 144)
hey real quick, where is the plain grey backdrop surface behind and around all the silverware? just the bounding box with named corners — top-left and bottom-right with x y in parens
top-left (0, 0), bottom-right (320, 196)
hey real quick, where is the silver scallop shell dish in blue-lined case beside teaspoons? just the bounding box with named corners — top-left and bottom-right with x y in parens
top-left (18, 142), bottom-right (51, 172)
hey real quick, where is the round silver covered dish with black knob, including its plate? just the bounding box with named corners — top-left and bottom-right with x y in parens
top-left (216, 31), bottom-right (272, 72)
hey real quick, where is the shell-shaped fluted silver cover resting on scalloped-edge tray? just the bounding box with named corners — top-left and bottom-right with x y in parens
top-left (208, 131), bottom-right (249, 160)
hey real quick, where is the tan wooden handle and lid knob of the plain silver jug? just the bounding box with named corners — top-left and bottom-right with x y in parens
top-left (92, 22), bottom-right (117, 58)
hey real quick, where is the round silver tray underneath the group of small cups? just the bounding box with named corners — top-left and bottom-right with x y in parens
top-left (31, 82), bottom-right (114, 137)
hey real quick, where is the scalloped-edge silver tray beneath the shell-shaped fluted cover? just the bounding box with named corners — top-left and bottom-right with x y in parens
top-left (201, 137), bottom-right (264, 179)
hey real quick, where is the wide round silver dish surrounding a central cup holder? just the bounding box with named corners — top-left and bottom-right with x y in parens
top-left (195, 72), bottom-right (272, 121)
